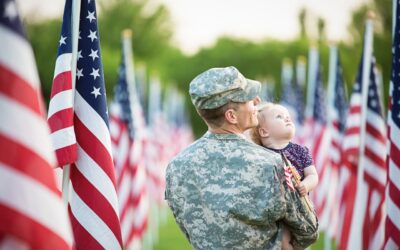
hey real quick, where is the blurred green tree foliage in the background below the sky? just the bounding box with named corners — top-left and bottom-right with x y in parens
top-left (27, 0), bottom-right (392, 136)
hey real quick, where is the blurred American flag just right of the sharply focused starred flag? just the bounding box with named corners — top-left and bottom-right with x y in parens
top-left (110, 32), bottom-right (148, 248)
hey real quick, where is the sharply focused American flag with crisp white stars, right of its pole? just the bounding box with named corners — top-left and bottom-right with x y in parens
top-left (49, 0), bottom-right (122, 249)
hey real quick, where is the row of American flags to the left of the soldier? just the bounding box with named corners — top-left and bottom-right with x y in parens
top-left (0, 0), bottom-right (193, 249)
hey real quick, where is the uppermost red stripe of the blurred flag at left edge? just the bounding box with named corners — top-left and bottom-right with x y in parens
top-left (0, 64), bottom-right (42, 116)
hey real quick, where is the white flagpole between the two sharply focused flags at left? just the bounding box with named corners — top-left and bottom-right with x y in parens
top-left (62, 0), bottom-right (81, 207)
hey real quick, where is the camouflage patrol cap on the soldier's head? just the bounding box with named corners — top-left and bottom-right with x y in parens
top-left (189, 66), bottom-right (261, 109)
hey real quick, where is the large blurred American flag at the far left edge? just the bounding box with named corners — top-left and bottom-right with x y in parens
top-left (0, 0), bottom-right (73, 249)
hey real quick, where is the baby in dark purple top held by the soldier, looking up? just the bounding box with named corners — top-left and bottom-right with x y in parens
top-left (251, 102), bottom-right (318, 249)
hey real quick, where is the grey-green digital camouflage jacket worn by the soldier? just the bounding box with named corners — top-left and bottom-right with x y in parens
top-left (165, 132), bottom-right (318, 249)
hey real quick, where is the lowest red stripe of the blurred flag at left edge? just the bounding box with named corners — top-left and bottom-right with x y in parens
top-left (0, 203), bottom-right (70, 250)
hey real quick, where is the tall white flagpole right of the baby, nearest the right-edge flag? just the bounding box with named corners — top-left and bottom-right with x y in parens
top-left (348, 12), bottom-right (373, 249)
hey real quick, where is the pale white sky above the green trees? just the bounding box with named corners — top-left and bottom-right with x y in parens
top-left (17, 0), bottom-right (369, 54)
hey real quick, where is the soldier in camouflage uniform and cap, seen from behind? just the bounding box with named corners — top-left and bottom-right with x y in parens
top-left (165, 67), bottom-right (318, 249)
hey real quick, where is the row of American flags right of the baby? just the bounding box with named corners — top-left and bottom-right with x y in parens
top-left (282, 9), bottom-right (400, 249)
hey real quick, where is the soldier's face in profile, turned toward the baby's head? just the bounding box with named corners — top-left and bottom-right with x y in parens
top-left (237, 96), bottom-right (260, 131)
